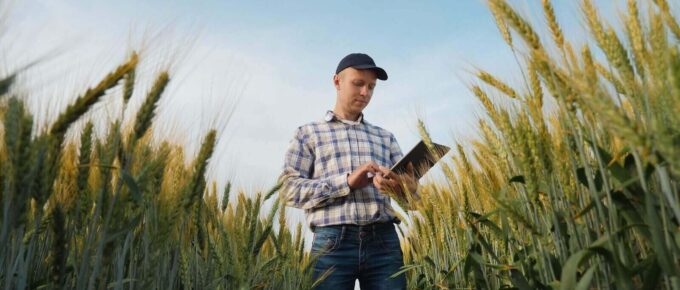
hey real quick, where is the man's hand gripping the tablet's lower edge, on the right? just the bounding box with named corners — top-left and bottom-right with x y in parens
top-left (373, 163), bottom-right (418, 198)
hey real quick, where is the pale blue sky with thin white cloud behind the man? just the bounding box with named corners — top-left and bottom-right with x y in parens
top-left (0, 0), bottom-right (636, 227)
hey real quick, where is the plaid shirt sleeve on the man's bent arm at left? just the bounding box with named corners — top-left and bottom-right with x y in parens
top-left (279, 127), bottom-right (350, 209)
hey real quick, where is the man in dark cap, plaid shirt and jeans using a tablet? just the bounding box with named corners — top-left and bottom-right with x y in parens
top-left (279, 53), bottom-right (418, 289)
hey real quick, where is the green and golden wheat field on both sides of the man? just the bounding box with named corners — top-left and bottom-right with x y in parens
top-left (0, 0), bottom-right (680, 290)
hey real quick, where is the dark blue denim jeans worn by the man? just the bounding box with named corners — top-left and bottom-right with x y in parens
top-left (312, 223), bottom-right (406, 290)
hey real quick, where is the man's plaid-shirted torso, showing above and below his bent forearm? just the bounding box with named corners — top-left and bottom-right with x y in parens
top-left (300, 112), bottom-right (401, 226)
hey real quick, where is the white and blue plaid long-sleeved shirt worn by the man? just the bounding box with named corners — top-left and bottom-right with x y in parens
top-left (279, 111), bottom-right (402, 227)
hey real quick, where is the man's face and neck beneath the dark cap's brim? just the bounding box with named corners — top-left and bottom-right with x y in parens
top-left (333, 67), bottom-right (377, 117)
